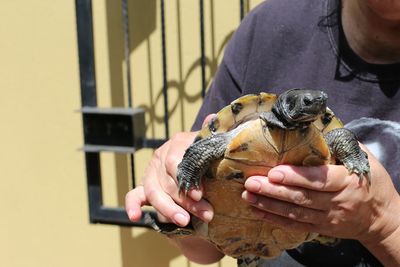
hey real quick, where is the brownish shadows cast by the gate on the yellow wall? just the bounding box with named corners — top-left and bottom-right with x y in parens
top-left (106, 0), bottom-right (232, 267)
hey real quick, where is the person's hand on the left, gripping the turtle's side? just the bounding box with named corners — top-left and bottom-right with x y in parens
top-left (125, 116), bottom-right (217, 226)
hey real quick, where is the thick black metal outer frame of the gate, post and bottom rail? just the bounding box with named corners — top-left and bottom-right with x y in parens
top-left (75, 0), bottom-right (159, 228)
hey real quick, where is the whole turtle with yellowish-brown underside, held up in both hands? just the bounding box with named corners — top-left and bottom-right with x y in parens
top-left (146, 88), bottom-right (371, 267)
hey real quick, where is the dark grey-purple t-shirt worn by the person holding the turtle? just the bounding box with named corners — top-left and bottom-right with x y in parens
top-left (193, 0), bottom-right (400, 266)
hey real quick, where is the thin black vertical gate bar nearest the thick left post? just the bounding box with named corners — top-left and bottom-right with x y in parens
top-left (122, 0), bottom-right (136, 188)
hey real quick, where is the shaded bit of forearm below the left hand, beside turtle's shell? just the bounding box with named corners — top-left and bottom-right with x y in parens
top-left (169, 236), bottom-right (224, 264)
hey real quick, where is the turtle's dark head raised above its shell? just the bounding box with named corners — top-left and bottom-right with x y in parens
top-left (272, 89), bottom-right (328, 128)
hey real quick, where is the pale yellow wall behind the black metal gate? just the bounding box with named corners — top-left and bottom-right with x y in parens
top-left (0, 0), bottom-right (260, 267)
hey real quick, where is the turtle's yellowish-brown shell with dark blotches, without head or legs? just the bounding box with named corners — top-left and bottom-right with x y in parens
top-left (194, 93), bottom-right (343, 258)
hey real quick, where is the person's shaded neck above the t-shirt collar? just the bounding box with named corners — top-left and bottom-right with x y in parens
top-left (341, 0), bottom-right (400, 64)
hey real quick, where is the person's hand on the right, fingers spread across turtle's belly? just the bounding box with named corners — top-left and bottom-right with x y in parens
top-left (242, 148), bottom-right (400, 246)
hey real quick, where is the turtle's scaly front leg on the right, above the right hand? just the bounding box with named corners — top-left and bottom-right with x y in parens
top-left (325, 128), bottom-right (371, 184)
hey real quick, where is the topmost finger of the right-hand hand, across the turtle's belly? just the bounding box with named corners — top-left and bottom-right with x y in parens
top-left (268, 165), bottom-right (357, 192)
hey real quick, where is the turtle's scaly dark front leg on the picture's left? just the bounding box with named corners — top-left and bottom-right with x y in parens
top-left (176, 133), bottom-right (230, 194)
